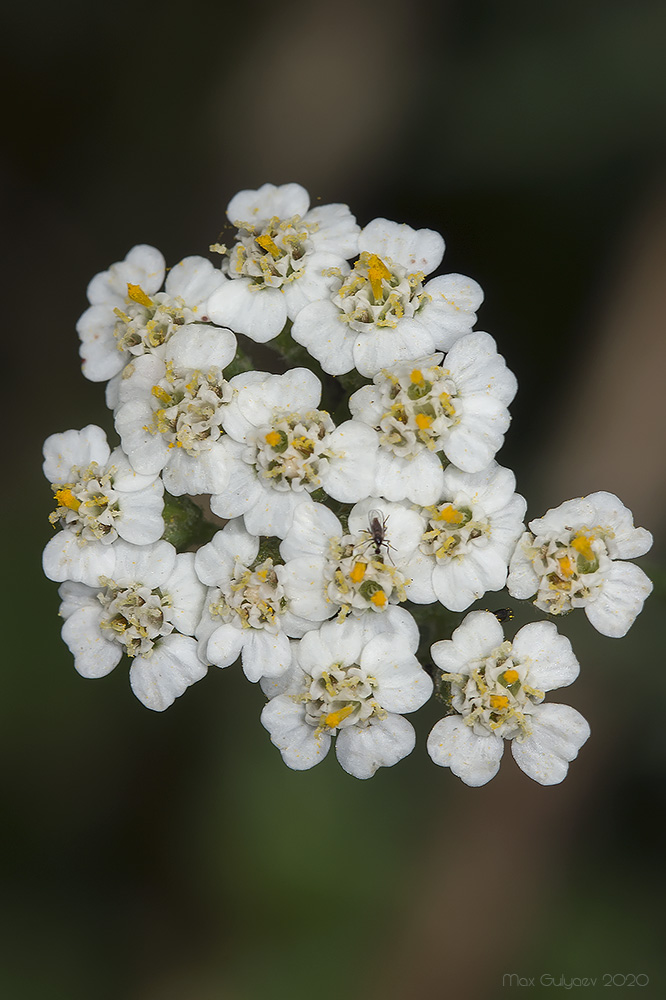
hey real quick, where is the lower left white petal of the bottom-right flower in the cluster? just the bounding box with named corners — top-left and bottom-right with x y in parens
top-left (427, 715), bottom-right (504, 788)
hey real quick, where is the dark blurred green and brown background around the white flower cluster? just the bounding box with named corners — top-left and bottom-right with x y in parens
top-left (0, 0), bottom-right (666, 1000)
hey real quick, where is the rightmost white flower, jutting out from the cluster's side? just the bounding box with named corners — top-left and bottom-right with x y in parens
top-left (507, 492), bottom-right (652, 638)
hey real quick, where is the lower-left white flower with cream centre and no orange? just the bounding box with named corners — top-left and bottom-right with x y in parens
top-left (60, 540), bottom-right (207, 712)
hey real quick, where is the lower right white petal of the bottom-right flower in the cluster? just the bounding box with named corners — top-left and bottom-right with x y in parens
top-left (511, 705), bottom-right (590, 785)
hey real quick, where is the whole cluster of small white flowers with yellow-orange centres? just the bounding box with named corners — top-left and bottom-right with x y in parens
top-left (43, 184), bottom-right (652, 785)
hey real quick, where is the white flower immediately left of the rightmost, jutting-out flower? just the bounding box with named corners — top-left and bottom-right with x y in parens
top-left (407, 461), bottom-right (527, 611)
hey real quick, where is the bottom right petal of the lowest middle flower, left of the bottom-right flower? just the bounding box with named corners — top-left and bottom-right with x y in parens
top-left (335, 714), bottom-right (416, 778)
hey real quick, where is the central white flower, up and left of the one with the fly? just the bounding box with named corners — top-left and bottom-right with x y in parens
top-left (210, 368), bottom-right (377, 538)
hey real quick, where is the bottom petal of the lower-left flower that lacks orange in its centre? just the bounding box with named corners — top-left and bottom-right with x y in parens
top-left (130, 635), bottom-right (208, 712)
